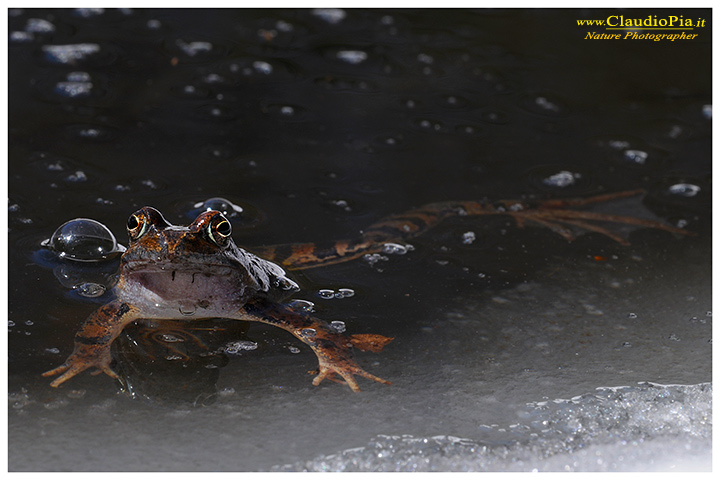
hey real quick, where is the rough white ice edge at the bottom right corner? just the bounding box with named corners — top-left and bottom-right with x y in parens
top-left (276, 383), bottom-right (712, 472)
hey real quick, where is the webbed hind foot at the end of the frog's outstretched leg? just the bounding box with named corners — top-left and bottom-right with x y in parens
top-left (504, 190), bottom-right (693, 245)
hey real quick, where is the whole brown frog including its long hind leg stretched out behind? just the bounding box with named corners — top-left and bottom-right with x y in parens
top-left (43, 189), bottom-right (692, 392)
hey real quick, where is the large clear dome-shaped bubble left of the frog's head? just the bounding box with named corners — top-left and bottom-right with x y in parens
top-left (42, 218), bottom-right (125, 262)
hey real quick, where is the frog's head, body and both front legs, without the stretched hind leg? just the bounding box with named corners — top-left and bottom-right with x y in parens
top-left (43, 206), bottom-right (393, 392)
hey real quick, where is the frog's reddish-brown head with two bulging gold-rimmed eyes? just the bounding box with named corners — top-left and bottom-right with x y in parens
top-left (122, 207), bottom-right (237, 273)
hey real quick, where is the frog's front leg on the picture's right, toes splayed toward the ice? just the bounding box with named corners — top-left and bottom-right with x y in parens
top-left (237, 302), bottom-right (392, 392)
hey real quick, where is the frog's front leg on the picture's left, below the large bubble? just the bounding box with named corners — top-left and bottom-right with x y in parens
top-left (43, 300), bottom-right (138, 387)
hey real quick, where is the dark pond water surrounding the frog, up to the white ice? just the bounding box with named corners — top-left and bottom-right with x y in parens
top-left (8, 9), bottom-right (712, 470)
